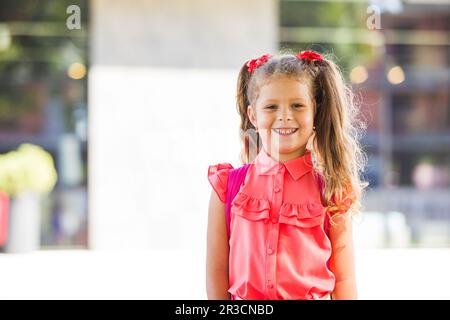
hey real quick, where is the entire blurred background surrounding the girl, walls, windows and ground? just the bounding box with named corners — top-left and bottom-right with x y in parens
top-left (0, 0), bottom-right (450, 299)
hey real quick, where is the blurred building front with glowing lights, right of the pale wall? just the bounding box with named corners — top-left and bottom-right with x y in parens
top-left (280, 0), bottom-right (450, 246)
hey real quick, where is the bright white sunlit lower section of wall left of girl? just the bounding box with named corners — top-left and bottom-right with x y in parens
top-left (89, 67), bottom-right (243, 249)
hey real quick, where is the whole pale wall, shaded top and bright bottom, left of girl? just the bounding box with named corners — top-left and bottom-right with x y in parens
top-left (89, 0), bottom-right (277, 250)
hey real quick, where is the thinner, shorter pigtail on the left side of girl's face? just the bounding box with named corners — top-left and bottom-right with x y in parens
top-left (236, 63), bottom-right (260, 163)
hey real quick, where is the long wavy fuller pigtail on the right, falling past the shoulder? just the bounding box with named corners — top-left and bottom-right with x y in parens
top-left (314, 59), bottom-right (368, 223)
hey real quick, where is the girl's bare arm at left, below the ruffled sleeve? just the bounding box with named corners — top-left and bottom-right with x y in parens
top-left (206, 190), bottom-right (230, 300)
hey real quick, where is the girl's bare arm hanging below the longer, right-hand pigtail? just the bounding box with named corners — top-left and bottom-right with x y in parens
top-left (330, 214), bottom-right (358, 300)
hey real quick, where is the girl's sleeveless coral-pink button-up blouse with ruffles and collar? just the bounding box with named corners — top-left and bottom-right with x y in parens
top-left (208, 149), bottom-right (335, 300)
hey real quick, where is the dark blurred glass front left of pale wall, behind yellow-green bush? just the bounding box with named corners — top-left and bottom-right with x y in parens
top-left (0, 1), bottom-right (89, 247)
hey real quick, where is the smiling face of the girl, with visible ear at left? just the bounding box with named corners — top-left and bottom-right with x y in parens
top-left (247, 78), bottom-right (314, 162)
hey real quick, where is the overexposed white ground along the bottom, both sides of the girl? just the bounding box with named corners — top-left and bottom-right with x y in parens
top-left (0, 249), bottom-right (450, 299)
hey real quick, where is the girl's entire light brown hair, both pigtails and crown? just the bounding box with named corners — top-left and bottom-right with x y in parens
top-left (236, 53), bottom-right (368, 223)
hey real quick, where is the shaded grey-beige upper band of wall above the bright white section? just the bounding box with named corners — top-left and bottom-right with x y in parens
top-left (91, 0), bottom-right (278, 69)
